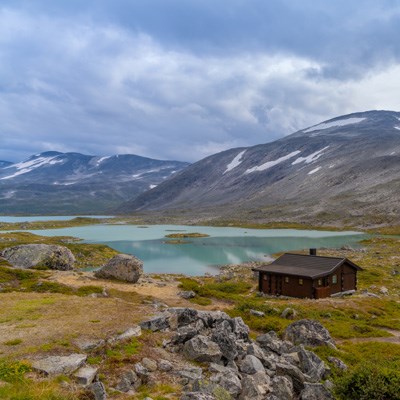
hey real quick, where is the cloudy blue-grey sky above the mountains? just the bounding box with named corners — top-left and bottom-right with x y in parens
top-left (0, 0), bottom-right (400, 161)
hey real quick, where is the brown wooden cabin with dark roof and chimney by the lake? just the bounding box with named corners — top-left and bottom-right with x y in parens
top-left (253, 249), bottom-right (362, 299)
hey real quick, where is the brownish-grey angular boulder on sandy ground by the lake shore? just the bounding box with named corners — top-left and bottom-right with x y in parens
top-left (94, 254), bottom-right (143, 283)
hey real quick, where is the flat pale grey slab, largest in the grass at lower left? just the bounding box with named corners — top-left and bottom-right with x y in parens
top-left (32, 354), bottom-right (87, 375)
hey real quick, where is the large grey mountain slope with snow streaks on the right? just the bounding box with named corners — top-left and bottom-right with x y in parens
top-left (121, 111), bottom-right (400, 225)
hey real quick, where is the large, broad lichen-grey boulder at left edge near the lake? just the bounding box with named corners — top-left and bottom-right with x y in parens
top-left (0, 244), bottom-right (75, 271)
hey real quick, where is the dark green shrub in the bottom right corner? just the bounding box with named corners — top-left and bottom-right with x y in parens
top-left (336, 364), bottom-right (400, 400)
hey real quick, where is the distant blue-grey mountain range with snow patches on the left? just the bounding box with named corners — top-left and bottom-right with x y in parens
top-left (0, 151), bottom-right (189, 214)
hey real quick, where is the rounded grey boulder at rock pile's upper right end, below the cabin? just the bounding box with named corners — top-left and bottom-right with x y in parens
top-left (283, 319), bottom-right (336, 349)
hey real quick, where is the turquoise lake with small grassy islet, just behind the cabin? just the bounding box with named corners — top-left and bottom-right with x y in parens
top-left (4, 222), bottom-right (366, 275)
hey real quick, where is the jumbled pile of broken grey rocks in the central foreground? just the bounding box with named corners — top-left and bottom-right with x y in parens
top-left (136, 308), bottom-right (332, 400)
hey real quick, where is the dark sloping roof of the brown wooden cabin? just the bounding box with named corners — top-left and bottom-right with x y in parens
top-left (254, 253), bottom-right (362, 278)
